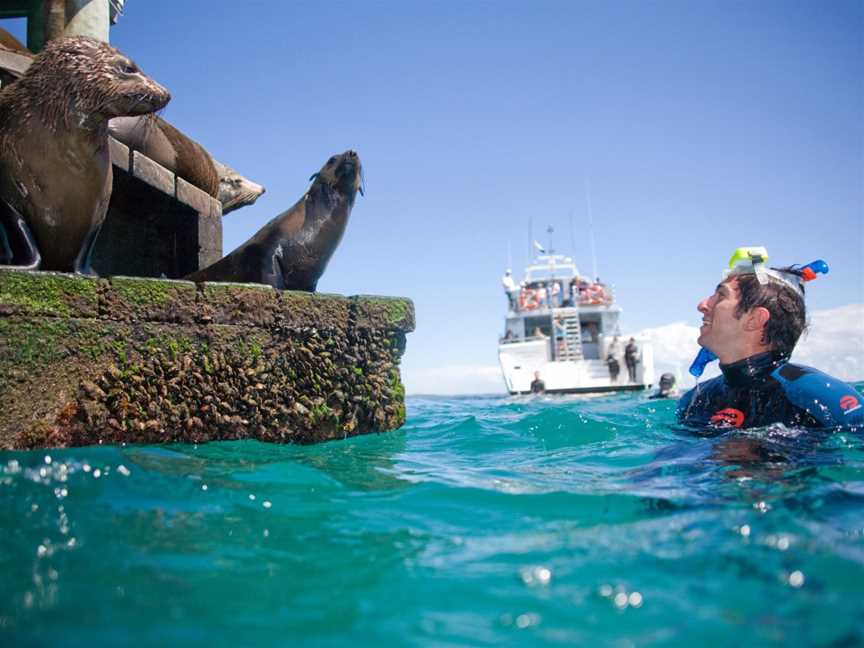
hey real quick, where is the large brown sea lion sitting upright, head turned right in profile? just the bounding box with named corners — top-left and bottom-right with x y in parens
top-left (0, 36), bottom-right (171, 272)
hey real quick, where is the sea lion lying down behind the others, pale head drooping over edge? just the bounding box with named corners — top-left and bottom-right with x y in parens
top-left (108, 115), bottom-right (264, 215)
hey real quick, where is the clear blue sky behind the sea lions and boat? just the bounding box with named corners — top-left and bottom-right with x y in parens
top-left (0, 0), bottom-right (864, 385)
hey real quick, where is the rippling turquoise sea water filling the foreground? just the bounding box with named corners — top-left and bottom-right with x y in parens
top-left (0, 387), bottom-right (864, 647)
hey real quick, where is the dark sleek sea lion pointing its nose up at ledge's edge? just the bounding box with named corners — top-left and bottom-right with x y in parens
top-left (186, 151), bottom-right (363, 292)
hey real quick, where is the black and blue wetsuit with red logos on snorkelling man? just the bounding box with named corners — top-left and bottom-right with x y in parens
top-left (678, 352), bottom-right (864, 431)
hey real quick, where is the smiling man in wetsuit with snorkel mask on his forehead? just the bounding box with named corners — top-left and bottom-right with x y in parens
top-left (678, 247), bottom-right (864, 430)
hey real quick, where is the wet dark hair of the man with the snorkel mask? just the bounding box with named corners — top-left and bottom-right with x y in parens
top-left (735, 268), bottom-right (807, 357)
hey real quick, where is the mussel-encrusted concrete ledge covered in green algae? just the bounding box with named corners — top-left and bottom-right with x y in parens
top-left (0, 270), bottom-right (414, 448)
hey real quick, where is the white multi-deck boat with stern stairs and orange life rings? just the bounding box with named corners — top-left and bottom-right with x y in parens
top-left (498, 254), bottom-right (654, 394)
